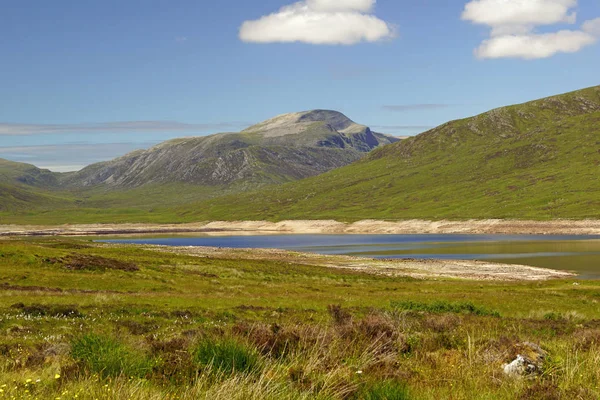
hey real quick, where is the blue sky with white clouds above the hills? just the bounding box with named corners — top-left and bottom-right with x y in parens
top-left (0, 0), bottom-right (600, 171)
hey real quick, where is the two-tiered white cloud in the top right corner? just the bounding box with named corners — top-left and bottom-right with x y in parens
top-left (462, 0), bottom-right (600, 60)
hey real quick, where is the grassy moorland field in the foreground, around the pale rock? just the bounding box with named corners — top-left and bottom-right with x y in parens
top-left (0, 238), bottom-right (600, 400)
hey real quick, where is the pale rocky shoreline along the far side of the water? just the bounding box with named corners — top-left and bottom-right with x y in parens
top-left (0, 219), bottom-right (600, 236)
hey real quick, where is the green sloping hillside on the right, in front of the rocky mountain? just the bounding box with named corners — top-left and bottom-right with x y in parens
top-left (179, 86), bottom-right (600, 220)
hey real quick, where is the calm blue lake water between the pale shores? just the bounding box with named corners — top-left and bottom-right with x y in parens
top-left (105, 235), bottom-right (600, 279)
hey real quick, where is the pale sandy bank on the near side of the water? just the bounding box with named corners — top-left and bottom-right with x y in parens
top-left (141, 246), bottom-right (575, 281)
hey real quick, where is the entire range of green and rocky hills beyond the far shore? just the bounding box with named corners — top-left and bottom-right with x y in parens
top-left (0, 86), bottom-right (600, 224)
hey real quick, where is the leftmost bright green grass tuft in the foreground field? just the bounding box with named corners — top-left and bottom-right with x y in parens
top-left (71, 334), bottom-right (152, 378)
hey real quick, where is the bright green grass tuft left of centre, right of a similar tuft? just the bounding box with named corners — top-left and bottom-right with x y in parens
top-left (192, 338), bottom-right (259, 375)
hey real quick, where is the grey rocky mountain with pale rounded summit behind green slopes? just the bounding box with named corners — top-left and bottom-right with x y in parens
top-left (60, 110), bottom-right (398, 189)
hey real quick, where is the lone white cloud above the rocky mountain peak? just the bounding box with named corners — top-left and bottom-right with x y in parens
top-left (239, 0), bottom-right (395, 45)
